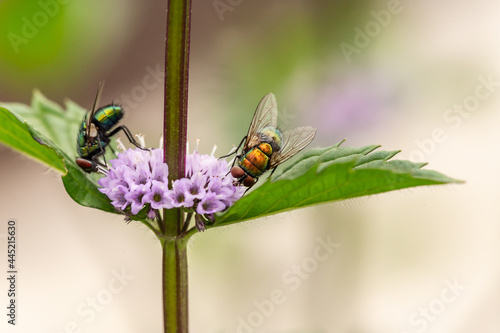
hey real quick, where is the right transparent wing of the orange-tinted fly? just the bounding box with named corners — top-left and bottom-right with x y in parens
top-left (269, 126), bottom-right (316, 169)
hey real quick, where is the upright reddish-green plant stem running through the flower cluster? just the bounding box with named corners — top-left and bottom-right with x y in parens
top-left (160, 0), bottom-right (191, 333)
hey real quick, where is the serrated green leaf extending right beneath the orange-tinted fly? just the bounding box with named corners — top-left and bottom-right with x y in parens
top-left (213, 142), bottom-right (461, 226)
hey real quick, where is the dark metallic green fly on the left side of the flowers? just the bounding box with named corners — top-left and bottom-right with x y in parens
top-left (76, 82), bottom-right (144, 173)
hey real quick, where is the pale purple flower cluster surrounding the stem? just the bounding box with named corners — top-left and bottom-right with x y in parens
top-left (99, 149), bottom-right (245, 219)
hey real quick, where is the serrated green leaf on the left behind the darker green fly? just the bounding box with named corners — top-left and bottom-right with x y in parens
top-left (0, 91), bottom-right (118, 214)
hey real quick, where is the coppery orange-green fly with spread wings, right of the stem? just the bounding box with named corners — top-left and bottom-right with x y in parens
top-left (222, 93), bottom-right (316, 188)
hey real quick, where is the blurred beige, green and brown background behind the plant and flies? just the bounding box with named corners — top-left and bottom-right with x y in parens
top-left (0, 0), bottom-right (500, 333)
